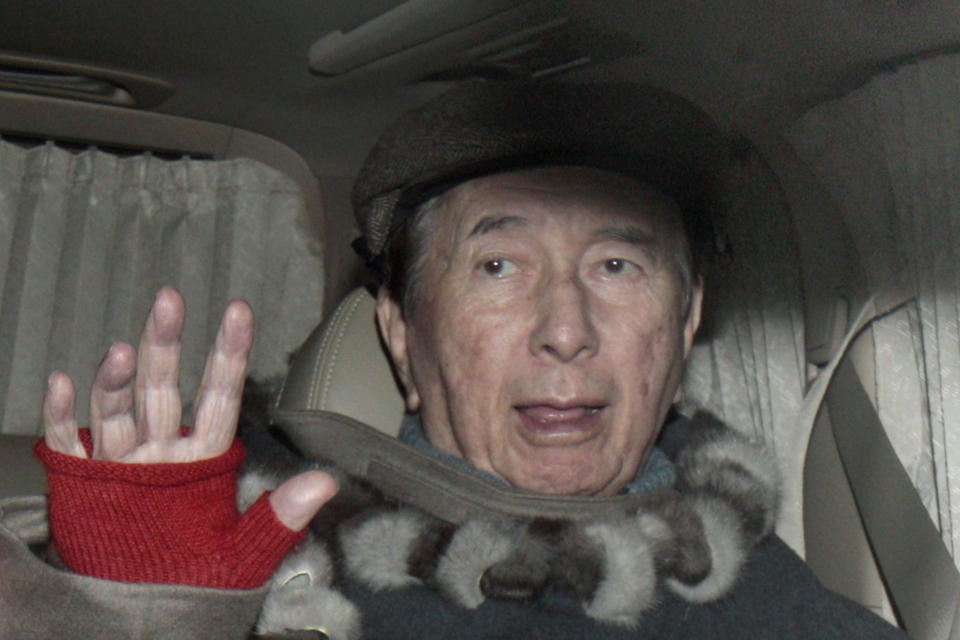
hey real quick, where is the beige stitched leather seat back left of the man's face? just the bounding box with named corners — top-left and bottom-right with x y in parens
top-left (278, 288), bottom-right (403, 435)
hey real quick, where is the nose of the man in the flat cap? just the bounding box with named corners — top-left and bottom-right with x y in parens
top-left (530, 275), bottom-right (599, 362)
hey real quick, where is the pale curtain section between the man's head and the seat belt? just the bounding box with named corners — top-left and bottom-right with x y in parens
top-left (682, 152), bottom-right (809, 553)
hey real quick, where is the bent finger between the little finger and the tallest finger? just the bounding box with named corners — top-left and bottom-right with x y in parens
top-left (90, 342), bottom-right (139, 460)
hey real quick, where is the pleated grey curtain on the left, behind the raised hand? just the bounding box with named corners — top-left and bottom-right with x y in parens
top-left (0, 140), bottom-right (323, 434)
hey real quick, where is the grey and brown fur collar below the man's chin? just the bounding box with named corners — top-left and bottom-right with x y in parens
top-left (241, 412), bottom-right (780, 639)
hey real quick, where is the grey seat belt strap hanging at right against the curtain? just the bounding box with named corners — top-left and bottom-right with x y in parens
top-left (805, 285), bottom-right (960, 640)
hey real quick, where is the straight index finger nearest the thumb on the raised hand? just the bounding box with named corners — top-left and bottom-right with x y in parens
top-left (192, 300), bottom-right (254, 457)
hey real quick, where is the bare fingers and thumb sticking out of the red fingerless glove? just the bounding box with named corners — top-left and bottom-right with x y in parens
top-left (43, 287), bottom-right (337, 530)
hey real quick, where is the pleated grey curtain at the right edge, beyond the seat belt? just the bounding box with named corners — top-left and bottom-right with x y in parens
top-left (790, 55), bottom-right (960, 559)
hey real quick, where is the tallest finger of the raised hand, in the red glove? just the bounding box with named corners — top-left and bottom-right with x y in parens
top-left (134, 287), bottom-right (185, 442)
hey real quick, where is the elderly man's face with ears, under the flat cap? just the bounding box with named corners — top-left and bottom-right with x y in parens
top-left (378, 167), bottom-right (701, 495)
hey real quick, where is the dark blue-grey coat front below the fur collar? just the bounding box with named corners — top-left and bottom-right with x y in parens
top-left (345, 538), bottom-right (906, 640)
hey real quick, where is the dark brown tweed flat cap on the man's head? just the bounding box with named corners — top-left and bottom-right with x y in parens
top-left (353, 81), bottom-right (724, 261)
